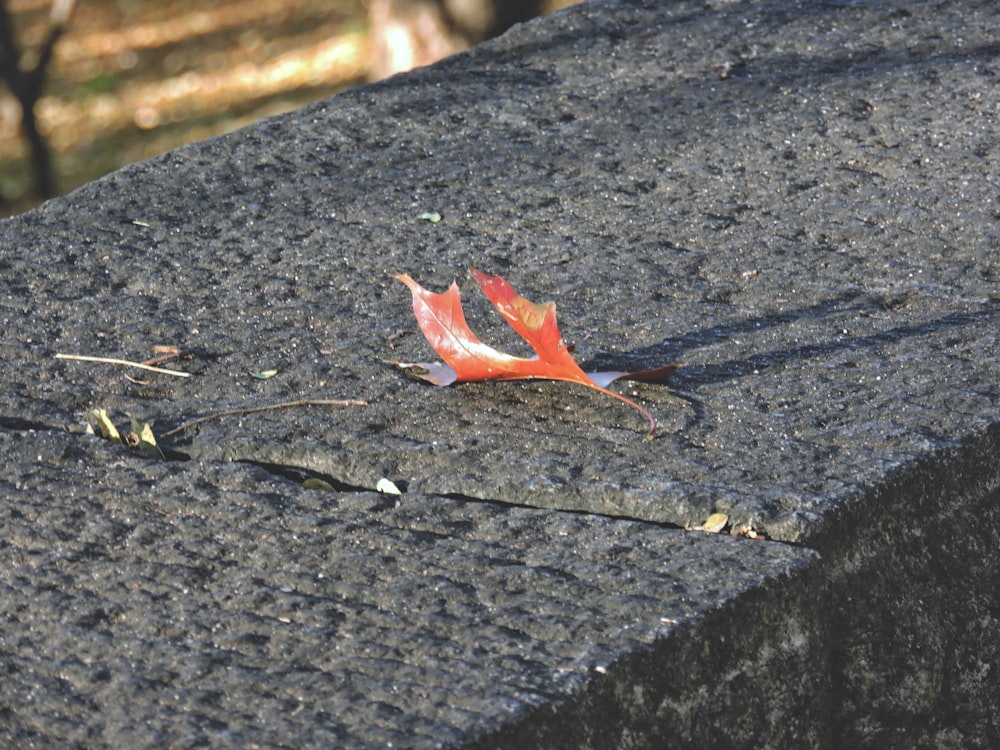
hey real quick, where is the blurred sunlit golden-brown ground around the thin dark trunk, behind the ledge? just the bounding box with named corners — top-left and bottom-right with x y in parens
top-left (0, 0), bottom-right (368, 215)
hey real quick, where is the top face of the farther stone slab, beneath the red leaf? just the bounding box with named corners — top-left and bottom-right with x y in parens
top-left (3, 3), bottom-right (1000, 541)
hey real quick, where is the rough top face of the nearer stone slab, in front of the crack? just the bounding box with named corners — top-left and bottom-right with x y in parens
top-left (0, 432), bottom-right (818, 747)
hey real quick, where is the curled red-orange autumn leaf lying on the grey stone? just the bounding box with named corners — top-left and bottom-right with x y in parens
top-left (393, 268), bottom-right (678, 438)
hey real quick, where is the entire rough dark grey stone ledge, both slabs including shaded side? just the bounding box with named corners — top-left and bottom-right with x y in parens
top-left (0, 0), bottom-right (1000, 747)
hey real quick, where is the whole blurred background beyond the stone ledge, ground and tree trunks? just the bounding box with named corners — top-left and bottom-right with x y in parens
top-left (0, 0), bottom-right (574, 217)
